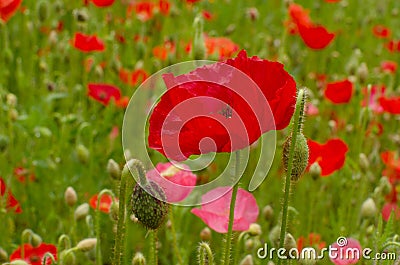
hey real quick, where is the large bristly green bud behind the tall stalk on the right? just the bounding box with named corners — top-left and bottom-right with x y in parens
top-left (283, 133), bottom-right (308, 181)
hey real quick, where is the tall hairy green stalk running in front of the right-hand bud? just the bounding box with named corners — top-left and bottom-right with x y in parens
top-left (278, 89), bottom-right (305, 265)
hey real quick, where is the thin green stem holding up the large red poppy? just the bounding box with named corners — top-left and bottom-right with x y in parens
top-left (222, 151), bottom-right (240, 265)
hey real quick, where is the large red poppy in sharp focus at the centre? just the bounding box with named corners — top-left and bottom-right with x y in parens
top-left (148, 51), bottom-right (296, 161)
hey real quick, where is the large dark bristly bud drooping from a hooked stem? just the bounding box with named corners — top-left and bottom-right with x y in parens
top-left (132, 181), bottom-right (168, 230)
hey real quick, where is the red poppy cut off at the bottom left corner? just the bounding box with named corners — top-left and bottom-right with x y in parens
top-left (10, 243), bottom-right (57, 265)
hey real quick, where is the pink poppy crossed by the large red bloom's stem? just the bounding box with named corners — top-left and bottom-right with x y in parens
top-left (191, 187), bottom-right (259, 233)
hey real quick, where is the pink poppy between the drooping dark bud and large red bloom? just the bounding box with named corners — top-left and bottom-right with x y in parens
top-left (146, 163), bottom-right (197, 202)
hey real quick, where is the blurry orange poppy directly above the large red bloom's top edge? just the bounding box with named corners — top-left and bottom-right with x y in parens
top-left (204, 36), bottom-right (239, 60)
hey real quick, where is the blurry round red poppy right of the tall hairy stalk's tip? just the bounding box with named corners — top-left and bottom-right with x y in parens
top-left (324, 79), bottom-right (353, 104)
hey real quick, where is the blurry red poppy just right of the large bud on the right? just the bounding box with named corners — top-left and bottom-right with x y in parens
top-left (307, 139), bottom-right (349, 176)
